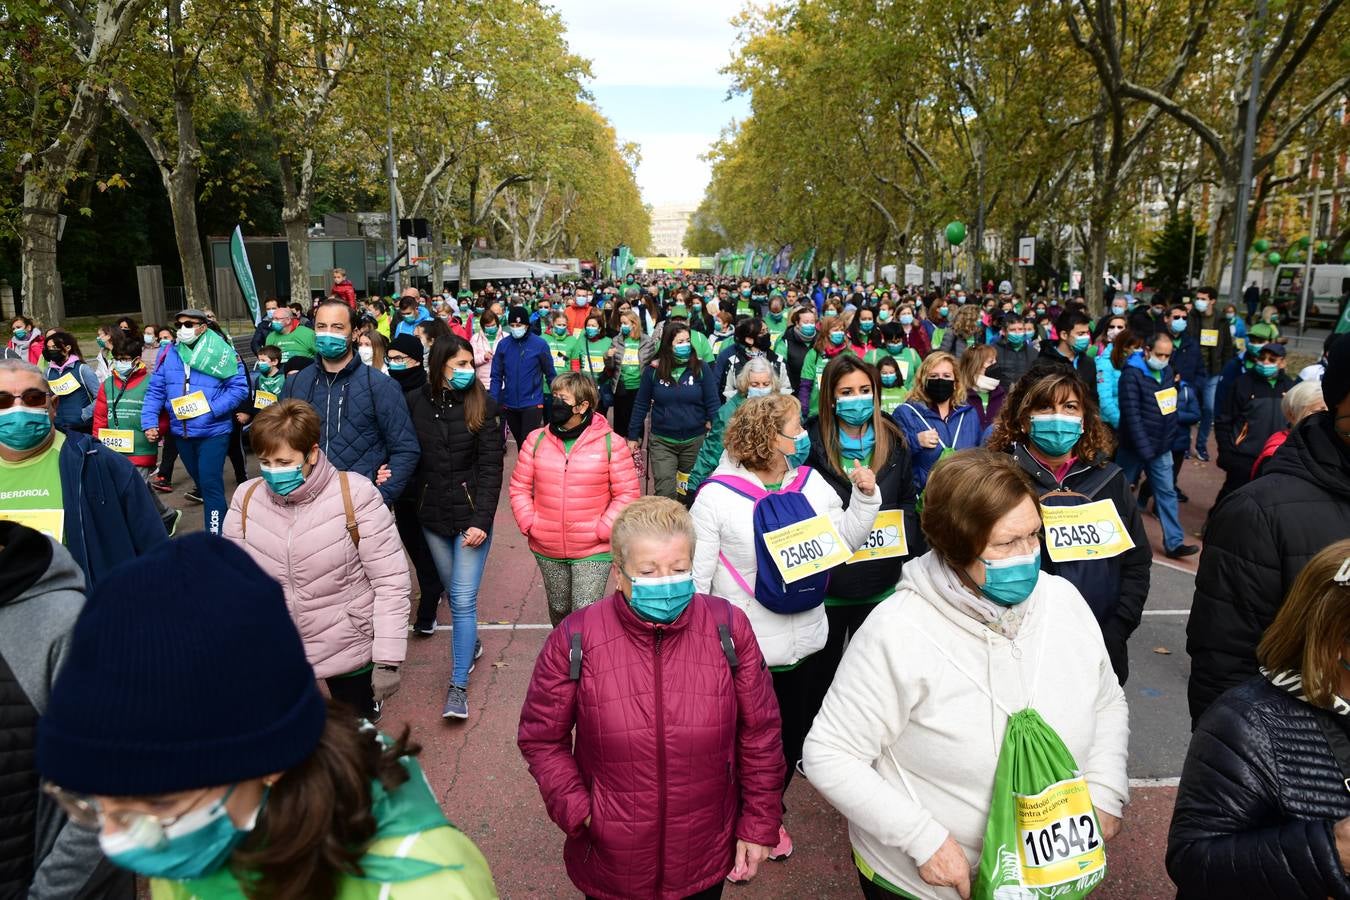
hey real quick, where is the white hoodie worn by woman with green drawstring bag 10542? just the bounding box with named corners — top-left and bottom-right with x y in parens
top-left (802, 552), bottom-right (1130, 899)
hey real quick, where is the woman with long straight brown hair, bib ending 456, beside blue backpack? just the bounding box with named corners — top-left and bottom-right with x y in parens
top-left (807, 354), bottom-right (926, 677)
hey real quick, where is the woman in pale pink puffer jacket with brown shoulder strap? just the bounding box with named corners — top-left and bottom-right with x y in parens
top-left (224, 399), bottom-right (412, 722)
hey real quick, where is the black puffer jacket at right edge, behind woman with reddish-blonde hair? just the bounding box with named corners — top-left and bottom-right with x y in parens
top-left (1185, 413), bottom-right (1350, 722)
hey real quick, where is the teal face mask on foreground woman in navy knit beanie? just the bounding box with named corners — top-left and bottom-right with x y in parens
top-left (99, 788), bottom-right (267, 881)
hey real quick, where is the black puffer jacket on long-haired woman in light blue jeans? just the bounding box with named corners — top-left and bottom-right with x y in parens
top-left (406, 385), bottom-right (505, 537)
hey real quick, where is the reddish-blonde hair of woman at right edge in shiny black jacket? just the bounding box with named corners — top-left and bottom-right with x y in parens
top-left (1257, 540), bottom-right (1350, 708)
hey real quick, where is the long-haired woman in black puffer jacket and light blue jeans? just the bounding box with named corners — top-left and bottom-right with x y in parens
top-left (405, 335), bottom-right (506, 719)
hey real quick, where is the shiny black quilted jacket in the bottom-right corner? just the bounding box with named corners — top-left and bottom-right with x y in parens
top-left (1166, 672), bottom-right (1350, 900)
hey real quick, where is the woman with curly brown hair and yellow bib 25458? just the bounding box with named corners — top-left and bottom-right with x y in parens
top-left (988, 366), bottom-right (1153, 684)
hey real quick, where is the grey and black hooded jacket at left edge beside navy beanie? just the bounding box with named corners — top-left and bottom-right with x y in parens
top-left (0, 521), bottom-right (132, 900)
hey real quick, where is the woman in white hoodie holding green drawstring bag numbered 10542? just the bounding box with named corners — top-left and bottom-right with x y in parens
top-left (803, 449), bottom-right (1129, 899)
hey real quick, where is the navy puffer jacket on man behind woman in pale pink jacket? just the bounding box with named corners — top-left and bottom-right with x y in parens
top-left (282, 354), bottom-right (421, 503)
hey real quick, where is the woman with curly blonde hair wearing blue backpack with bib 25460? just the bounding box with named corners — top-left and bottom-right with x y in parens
top-left (690, 394), bottom-right (882, 860)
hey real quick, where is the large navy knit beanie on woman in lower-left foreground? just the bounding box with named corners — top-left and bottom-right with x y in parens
top-left (38, 534), bottom-right (327, 796)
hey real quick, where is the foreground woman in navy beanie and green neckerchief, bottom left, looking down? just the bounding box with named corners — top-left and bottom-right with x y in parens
top-left (38, 534), bottom-right (495, 900)
